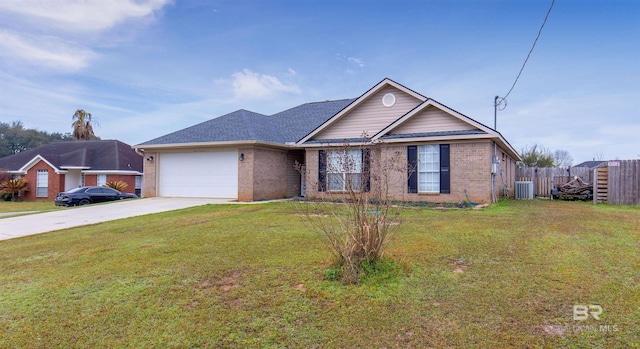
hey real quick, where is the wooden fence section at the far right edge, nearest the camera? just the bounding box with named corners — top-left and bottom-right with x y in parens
top-left (593, 160), bottom-right (640, 205)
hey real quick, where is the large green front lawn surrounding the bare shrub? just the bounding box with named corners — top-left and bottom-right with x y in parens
top-left (0, 201), bottom-right (640, 348)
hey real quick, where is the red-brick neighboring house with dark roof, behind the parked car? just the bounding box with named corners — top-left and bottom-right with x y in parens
top-left (0, 140), bottom-right (143, 201)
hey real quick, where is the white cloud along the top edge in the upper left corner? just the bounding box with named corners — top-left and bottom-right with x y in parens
top-left (0, 0), bottom-right (171, 31)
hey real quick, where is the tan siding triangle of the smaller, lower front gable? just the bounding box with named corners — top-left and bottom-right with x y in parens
top-left (389, 106), bottom-right (477, 134)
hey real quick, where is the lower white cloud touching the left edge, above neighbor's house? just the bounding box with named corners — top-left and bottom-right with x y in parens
top-left (0, 31), bottom-right (97, 71)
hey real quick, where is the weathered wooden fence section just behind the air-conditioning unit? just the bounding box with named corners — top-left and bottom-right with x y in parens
top-left (516, 167), bottom-right (592, 197)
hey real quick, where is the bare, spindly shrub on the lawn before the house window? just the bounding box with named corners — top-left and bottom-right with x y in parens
top-left (300, 142), bottom-right (407, 283)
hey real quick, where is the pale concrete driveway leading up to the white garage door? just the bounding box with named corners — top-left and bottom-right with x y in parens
top-left (0, 198), bottom-right (233, 240)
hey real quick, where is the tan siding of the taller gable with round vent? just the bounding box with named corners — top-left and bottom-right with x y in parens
top-left (313, 86), bottom-right (421, 139)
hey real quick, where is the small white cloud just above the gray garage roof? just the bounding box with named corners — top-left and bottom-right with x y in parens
top-left (231, 69), bottom-right (300, 99)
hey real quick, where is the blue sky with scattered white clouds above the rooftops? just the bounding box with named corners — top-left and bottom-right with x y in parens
top-left (0, 0), bottom-right (640, 164)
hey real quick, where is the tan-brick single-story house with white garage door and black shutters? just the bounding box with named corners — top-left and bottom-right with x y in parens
top-left (134, 79), bottom-right (521, 202)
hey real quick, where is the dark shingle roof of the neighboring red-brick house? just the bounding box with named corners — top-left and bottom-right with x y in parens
top-left (0, 140), bottom-right (142, 172)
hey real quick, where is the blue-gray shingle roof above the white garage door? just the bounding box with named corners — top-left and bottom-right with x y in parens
top-left (137, 99), bottom-right (355, 146)
